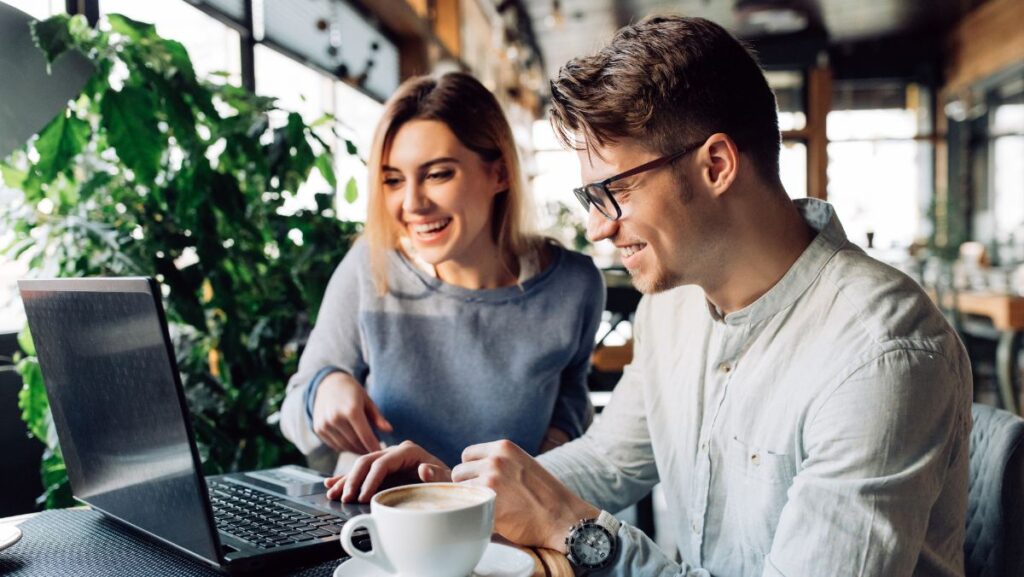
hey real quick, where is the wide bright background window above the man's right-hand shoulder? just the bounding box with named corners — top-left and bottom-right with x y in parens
top-left (826, 82), bottom-right (933, 249)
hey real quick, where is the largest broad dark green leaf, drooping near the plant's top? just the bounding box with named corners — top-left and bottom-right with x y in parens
top-left (100, 85), bottom-right (167, 182)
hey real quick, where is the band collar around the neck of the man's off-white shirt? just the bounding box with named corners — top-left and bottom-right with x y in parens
top-left (708, 199), bottom-right (848, 325)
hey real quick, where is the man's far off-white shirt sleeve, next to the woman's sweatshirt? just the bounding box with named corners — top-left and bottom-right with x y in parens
top-left (538, 293), bottom-right (657, 510)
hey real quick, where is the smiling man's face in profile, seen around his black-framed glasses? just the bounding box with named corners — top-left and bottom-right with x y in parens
top-left (579, 141), bottom-right (723, 293)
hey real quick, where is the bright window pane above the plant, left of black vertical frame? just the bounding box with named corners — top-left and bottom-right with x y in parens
top-left (99, 0), bottom-right (242, 85)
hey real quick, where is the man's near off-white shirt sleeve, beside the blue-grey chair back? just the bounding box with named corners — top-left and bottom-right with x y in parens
top-left (764, 349), bottom-right (971, 577)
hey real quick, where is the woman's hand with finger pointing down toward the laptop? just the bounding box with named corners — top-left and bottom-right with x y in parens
top-left (313, 372), bottom-right (393, 455)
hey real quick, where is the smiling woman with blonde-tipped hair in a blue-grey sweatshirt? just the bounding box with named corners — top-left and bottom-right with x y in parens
top-left (282, 74), bottom-right (604, 471)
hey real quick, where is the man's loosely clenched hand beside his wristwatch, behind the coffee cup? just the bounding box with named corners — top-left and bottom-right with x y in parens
top-left (452, 441), bottom-right (601, 552)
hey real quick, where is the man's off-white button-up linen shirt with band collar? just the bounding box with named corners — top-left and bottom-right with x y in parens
top-left (541, 200), bottom-right (972, 577)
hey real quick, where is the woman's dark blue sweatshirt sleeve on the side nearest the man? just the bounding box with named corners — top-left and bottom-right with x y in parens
top-left (551, 259), bottom-right (605, 439)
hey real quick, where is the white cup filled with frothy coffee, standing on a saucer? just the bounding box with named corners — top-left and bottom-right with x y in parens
top-left (341, 483), bottom-right (495, 577)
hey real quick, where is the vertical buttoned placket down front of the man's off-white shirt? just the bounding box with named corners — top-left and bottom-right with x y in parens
top-left (690, 323), bottom-right (748, 567)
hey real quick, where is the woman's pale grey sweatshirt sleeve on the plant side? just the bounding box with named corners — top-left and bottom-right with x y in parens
top-left (281, 240), bottom-right (370, 455)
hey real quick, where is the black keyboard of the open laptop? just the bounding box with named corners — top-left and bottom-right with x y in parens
top-left (208, 481), bottom-right (345, 549)
